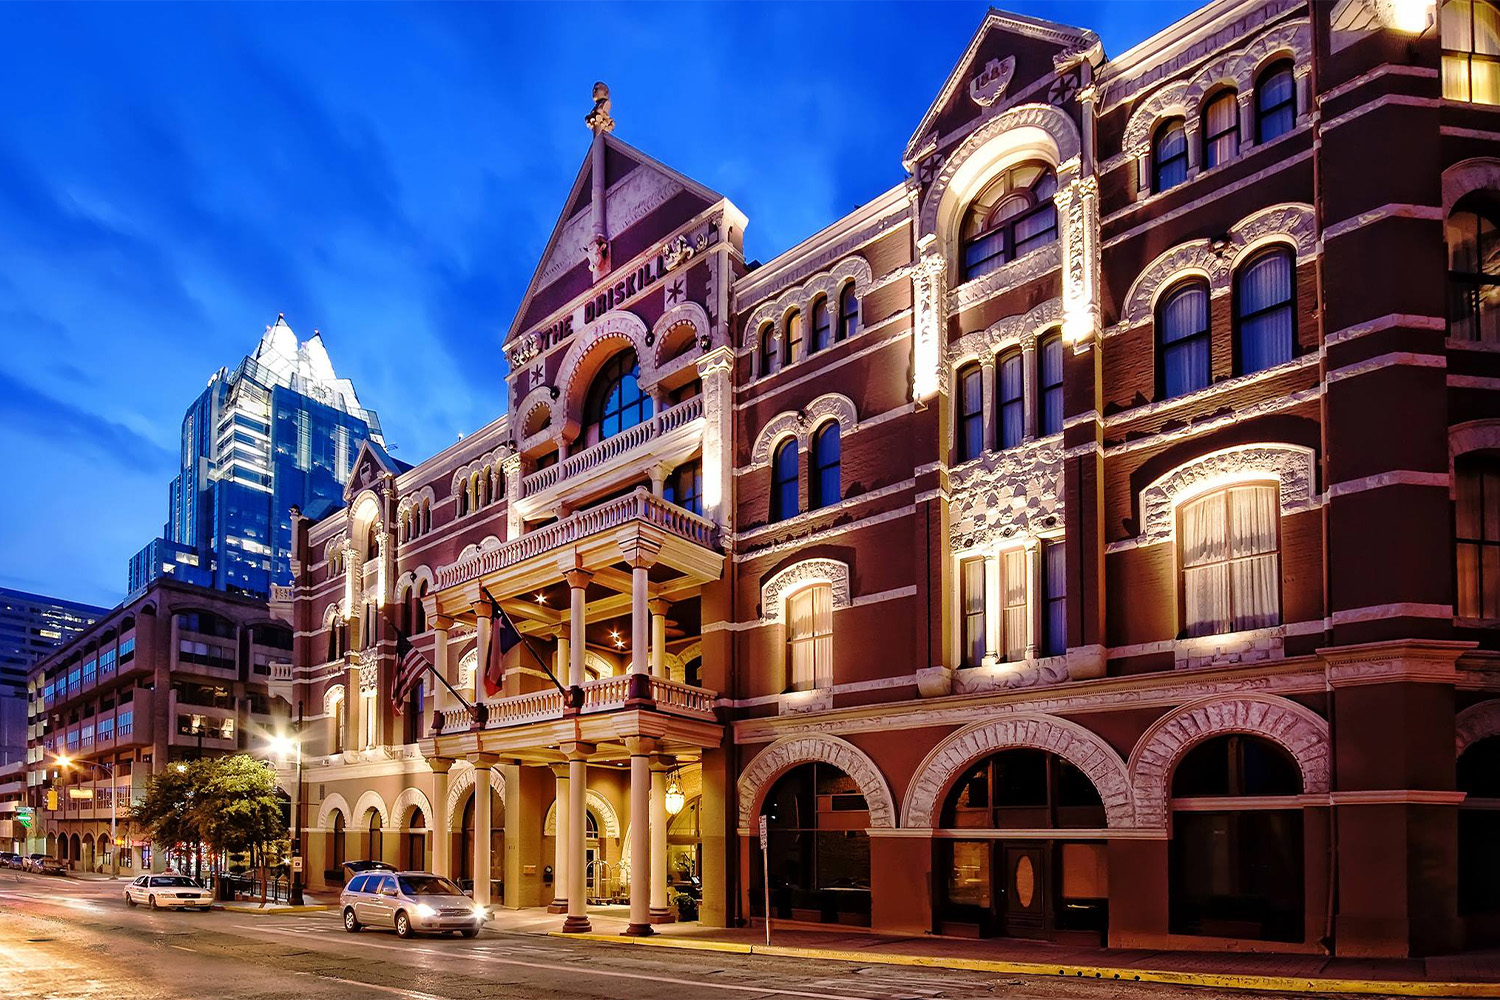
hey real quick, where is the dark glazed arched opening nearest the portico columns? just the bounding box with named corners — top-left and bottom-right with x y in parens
top-left (750, 762), bottom-right (870, 927)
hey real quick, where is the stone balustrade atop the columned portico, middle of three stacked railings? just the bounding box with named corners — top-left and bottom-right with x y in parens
top-left (438, 488), bottom-right (717, 589)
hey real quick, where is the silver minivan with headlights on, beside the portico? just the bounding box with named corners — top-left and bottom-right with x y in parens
top-left (339, 871), bottom-right (489, 937)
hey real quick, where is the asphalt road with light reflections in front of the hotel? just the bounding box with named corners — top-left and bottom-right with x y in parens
top-left (0, 871), bottom-right (1326, 1000)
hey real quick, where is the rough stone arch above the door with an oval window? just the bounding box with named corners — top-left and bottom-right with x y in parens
top-left (902, 715), bottom-right (1136, 829)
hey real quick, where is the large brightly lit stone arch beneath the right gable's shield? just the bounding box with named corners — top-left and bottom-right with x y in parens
top-left (917, 103), bottom-right (1082, 243)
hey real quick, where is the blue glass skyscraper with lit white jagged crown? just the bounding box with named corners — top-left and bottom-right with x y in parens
top-left (129, 316), bottom-right (384, 597)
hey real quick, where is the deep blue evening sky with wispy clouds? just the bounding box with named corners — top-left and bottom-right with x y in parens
top-left (0, 0), bottom-right (1199, 604)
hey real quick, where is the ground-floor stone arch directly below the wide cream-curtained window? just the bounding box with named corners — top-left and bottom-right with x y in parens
top-left (1130, 694), bottom-right (1332, 829)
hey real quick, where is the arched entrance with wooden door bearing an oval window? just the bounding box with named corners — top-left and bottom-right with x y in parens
top-left (933, 748), bottom-right (1109, 942)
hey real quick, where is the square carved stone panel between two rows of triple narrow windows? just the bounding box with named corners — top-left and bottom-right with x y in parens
top-left (948, 442), bottom-right (1064, 550)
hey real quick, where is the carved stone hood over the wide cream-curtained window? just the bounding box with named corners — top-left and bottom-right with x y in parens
top-left (1140, 442), bottom-right (1317, 546)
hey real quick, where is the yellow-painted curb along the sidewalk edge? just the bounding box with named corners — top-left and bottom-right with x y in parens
top-left (548, 931), bottom-right (1500, 997)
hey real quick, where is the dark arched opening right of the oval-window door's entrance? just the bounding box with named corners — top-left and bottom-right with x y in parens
top-left (1167, 733), bottom-right (1307, 942)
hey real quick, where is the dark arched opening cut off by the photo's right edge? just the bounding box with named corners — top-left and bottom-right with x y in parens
top-left (1458, 735), bottom-right (1500, 948)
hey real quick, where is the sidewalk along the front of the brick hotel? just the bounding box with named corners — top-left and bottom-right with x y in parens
top-left (489, 907), bottom-right (1500, 997)
